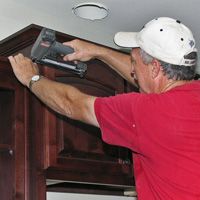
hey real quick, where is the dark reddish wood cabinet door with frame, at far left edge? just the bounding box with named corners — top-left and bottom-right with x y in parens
top-left (0, 59), bottom-right (28, 200)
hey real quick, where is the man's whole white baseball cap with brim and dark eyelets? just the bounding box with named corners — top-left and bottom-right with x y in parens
top-left (114, 17), bottom-right (197, 66)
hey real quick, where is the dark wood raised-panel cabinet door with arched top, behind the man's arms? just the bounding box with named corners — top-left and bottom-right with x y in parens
top-left (32, 61), bottom-right (133, 187)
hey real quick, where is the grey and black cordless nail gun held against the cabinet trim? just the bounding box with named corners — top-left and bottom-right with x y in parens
top-left (31, 28), bottom-right (87, 77)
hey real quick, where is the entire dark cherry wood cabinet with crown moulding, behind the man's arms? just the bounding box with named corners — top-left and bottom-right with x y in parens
top-left (0, 25), bottom-right (134, 200)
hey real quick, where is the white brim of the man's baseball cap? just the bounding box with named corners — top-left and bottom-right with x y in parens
top-left (114, 32), bottom-right (139, 48)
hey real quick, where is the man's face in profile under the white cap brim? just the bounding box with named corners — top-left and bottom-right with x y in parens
top-left (131, 48), bottom-right (152, 93)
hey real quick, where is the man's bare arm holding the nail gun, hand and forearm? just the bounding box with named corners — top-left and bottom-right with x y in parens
top-left (64, 39), bottom-right (136, 85)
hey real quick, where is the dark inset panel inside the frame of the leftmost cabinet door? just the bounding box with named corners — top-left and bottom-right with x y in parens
top-left (0, 87), bottom-right (15, 200)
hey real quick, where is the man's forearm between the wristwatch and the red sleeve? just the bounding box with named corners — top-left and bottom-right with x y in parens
top-left (31, 77), bottom-right (98, 126)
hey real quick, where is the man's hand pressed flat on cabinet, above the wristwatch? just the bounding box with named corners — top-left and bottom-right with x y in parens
top-left (8, 54), bottom-right (39, 87)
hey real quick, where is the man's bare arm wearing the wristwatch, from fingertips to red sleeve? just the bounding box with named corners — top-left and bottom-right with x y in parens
top-left (9, 54), bottom-right (99, 127)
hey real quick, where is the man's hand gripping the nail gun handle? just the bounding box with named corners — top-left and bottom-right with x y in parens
top-left (63, 39), bottom-right (101, 62)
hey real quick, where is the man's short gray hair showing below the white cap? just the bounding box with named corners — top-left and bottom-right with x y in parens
top-left (140, 49), bottom-right (197, 80)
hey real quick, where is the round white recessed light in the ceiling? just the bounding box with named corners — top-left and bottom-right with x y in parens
top-left (72, 2), bottom-right (108, 20)
